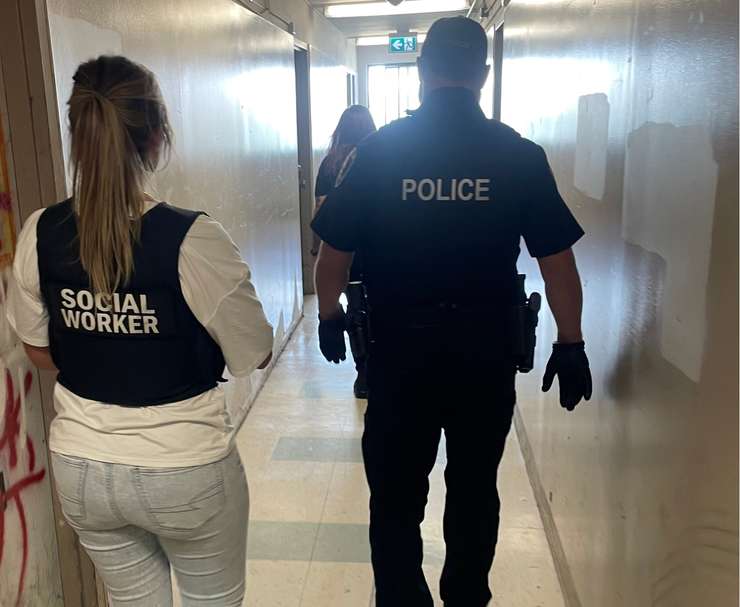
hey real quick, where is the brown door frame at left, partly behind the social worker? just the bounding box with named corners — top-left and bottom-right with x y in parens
top-left (0, 0), bottom-right (107, 607)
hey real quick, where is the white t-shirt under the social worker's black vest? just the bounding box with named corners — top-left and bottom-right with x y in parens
top-left (7, 202), bottom-right (273, 467)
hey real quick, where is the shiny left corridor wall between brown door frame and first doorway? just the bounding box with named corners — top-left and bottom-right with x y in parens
top-left (48, 0), bottom-right (303, 422)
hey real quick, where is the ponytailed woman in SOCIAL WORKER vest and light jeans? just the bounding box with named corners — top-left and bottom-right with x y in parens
top-left (8, 56), bottom-right (273, 607)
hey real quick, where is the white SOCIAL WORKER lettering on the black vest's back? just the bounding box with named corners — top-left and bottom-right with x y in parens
top-left (60, 289), bottom-right (159, 335)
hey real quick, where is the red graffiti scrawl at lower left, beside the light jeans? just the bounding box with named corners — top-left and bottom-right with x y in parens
top-left (0, 369), bottom-right (46, 606)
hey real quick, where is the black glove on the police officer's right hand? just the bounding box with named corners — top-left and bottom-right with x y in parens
top-left (542, 341), bottom-right (591, 411)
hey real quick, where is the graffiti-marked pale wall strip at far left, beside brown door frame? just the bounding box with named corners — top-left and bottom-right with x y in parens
top-left (0, 70), bottom-right (63, 607)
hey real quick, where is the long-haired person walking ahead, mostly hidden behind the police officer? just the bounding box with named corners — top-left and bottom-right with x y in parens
top-left (311, 105), bottom-right (377, 399)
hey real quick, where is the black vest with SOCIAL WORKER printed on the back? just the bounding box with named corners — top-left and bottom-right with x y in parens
top-left (37, 200), bottom-right (225, 407)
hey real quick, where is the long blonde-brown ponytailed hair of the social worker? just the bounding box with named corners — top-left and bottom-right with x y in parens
top-left (68, 56), bottom-right (172, 295)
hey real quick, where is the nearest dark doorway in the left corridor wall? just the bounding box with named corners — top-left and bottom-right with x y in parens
top-left (293, 46), bottom-right (315, 295)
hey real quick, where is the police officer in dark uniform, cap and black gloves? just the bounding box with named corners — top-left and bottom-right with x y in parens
top-left (313, 17), bottom-right (591, 607)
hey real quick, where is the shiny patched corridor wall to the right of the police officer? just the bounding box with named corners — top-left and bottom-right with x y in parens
top-left (502, 0), bottom-right (738, 607)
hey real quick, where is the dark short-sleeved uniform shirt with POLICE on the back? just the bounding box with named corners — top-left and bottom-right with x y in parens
top-left (312, 88), bottom-right (584, 310)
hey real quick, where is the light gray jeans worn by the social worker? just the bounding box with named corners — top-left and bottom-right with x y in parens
top-left (52, 449), bottom-right (249, 607)
